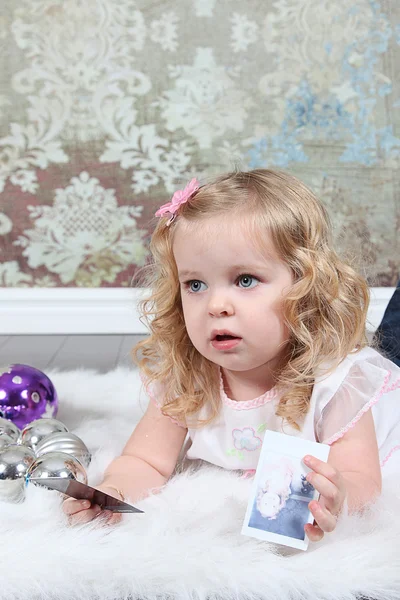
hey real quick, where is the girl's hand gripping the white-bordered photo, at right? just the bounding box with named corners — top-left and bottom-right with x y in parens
top-left (303, 456), bottom-right (347, 542)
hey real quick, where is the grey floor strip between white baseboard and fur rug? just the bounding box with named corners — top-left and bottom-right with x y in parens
top-left (0, 335), bottom-right (144, 372)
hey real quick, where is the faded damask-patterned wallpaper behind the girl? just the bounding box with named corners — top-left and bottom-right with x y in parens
top-left (0, 0), bottom-right (400, 287)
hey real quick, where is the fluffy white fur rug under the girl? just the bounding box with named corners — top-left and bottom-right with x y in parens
top-left (0, 368), bottom-right (400, 600)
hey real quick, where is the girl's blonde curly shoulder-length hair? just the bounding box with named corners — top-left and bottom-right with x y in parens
top-left (132, 169), bottom-right (369, 429)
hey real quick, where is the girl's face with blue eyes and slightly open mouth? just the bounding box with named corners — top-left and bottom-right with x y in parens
top-left (173, 216), bottom-right (293, 385)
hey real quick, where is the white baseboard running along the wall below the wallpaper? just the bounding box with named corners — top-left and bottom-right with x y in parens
top-left (0, 288), bottom-right (395, 335)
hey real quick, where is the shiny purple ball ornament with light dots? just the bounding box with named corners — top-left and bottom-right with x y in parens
top-left (0, 364), bottom-right (58, 429)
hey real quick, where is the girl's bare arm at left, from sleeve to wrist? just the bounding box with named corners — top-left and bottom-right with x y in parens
top-left (101, 402), bottom-right (187, 502)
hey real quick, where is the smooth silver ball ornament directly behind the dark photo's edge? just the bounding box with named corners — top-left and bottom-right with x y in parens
top-left (26, 452), bottom-right (87, 485)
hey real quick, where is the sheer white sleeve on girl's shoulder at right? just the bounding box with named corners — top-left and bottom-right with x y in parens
top-left (314, 352), bottom-right (399, 445)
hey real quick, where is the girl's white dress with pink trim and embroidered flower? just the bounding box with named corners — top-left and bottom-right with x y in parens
top-left (145, 347), bottom-right (400, 472)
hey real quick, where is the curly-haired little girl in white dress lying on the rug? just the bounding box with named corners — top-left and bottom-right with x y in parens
top-left (64, 169), bottom-right (400, 540)
